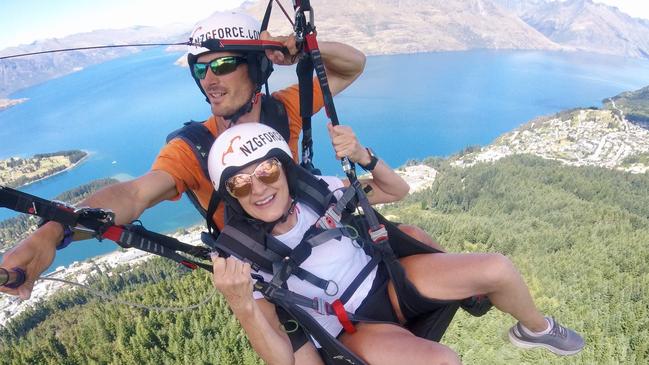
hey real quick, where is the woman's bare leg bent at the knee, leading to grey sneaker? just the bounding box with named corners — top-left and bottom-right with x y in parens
top-left (393, 253), bottom-right (548, 332)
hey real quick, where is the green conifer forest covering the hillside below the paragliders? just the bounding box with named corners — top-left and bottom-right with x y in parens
top-left (0, 155), bottom-right (649, 364)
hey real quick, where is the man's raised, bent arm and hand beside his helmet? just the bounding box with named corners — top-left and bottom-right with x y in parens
top-left (260, 31), bottom-right (365, 95)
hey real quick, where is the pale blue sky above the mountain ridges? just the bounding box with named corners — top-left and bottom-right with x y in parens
top-left (0, 0), bottom-right (649, 49)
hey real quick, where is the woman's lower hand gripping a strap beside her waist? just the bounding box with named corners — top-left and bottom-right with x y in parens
top-left (211, 253), bottom-right (254, 313)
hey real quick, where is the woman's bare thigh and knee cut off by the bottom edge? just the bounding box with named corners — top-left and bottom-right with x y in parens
top-left (340, 323), bottom-right (460, 365)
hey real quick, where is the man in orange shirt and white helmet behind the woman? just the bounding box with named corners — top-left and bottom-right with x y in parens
top-left (0, 12), bottom-right (365, 292)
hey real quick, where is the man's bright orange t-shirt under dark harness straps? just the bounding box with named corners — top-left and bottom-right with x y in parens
top-left (151, 79), bottom-right (324, 229)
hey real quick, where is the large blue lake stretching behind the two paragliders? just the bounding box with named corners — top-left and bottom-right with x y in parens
top-left (0, 49), bottom-right (649, 267)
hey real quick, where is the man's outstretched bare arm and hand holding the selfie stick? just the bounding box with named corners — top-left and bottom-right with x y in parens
top-left (0, 171), bottom-right (178, 299)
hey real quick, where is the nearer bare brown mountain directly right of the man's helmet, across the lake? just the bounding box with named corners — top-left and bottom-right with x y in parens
top-left (243, 0), bottom-right (561, 55)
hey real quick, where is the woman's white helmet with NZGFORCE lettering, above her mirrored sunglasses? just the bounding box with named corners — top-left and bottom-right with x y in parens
top-left (207, 122), bottom-right (292, 195)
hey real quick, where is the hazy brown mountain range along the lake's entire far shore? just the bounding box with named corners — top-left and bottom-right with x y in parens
top-left (0, 0), bottom-right (649, 98)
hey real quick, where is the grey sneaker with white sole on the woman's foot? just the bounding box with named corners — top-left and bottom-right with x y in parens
top-left (509, 317), bottom-right (584, 355)
